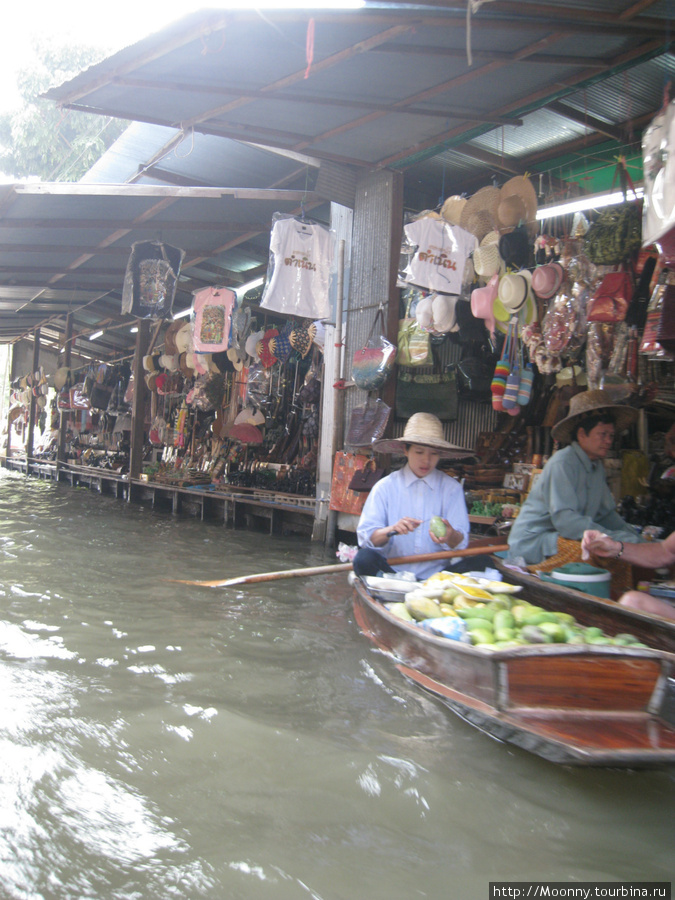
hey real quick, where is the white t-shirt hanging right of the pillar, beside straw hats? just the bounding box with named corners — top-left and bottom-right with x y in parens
top-left (403, 216), bottom-right (477, 294)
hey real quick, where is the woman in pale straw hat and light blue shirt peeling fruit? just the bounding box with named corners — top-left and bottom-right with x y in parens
top-left (353, 413), bottom-right (489, 580)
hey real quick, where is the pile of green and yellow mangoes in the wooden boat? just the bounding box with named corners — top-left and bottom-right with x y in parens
top-left (396, 585), bottom-right (646, 650)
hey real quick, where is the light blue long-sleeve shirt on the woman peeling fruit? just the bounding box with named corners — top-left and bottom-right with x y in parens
top-left (356, 465), bottom-right (469, 580)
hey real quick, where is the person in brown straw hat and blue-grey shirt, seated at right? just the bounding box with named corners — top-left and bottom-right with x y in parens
top-left (508, 391), bottom-right (641, 568)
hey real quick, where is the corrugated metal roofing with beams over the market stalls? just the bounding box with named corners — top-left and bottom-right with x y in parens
top-left (0, 0), bottom-right (675, 352)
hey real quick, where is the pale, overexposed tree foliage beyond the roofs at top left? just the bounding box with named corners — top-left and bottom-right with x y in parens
top-left (0, 38), bottom-right (127, 181)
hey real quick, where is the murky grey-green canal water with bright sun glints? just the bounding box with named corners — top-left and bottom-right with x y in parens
top-left (0, 470), bottom-right (675, 900)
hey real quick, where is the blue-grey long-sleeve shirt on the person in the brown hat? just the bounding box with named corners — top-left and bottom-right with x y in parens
top-left (508, 441), bottom-right (641, 565)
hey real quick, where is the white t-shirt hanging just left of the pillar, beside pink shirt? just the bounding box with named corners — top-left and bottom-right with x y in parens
top-left (260, 219), bottom-right (333, 319)
